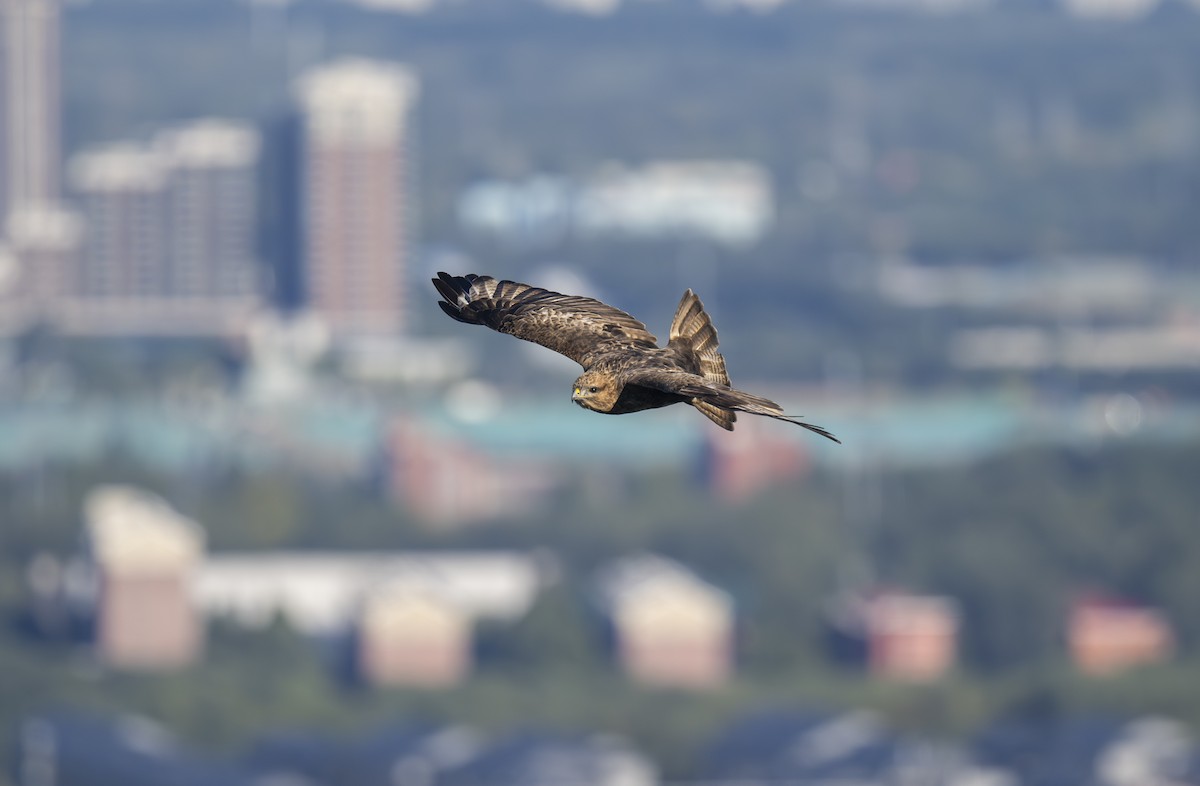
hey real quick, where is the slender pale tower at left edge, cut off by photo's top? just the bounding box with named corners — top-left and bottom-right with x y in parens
top-left (0, 0), bottom-right (61, 234)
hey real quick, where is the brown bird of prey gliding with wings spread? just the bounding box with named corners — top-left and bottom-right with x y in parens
top-left (433, 272), bottom-right (841, 444)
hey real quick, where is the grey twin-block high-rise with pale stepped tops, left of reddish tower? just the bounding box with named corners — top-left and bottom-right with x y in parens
top-left (67, 120), bottom-right (260, 332)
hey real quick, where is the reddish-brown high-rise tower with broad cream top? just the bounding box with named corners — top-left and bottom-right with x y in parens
top-left (298, 60), bottom-right (419, 337)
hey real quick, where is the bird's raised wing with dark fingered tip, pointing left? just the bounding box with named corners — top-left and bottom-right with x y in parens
top-left (433, 272), bottom-right (658, 368)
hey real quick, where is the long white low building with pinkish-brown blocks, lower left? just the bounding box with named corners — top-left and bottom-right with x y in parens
top-left (48, 486), bottom-right (558, 685)
